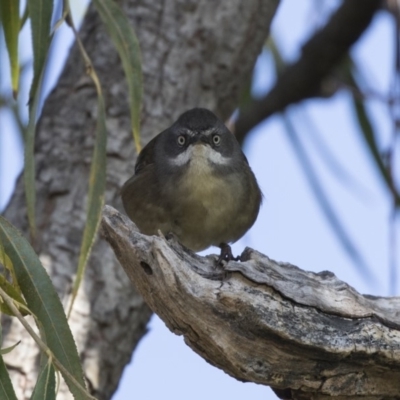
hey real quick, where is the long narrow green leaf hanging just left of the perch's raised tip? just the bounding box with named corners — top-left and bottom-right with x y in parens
top-left (68, 93), bottom-right (107, 316)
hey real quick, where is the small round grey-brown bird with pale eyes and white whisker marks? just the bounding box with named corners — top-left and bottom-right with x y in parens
top-left (121, 108), bottom-right (262, 262)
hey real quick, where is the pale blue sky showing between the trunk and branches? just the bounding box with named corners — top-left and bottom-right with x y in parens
top-left (0, 0), bottom-right (400, 400)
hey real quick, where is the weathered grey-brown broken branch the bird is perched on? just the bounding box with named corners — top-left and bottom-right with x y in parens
top-left (102, 206), bottom-right (400, 400)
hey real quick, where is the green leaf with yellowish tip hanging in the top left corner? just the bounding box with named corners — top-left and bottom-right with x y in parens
top-left (0, 0), bottom-right (20, 98)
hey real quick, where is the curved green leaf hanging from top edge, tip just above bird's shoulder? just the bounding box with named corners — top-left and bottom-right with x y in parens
top-left (94, 0), bottom-right (143, 153)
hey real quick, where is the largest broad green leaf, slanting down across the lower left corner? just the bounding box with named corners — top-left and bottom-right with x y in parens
top-left (0, 216), bottom-right (86, 399)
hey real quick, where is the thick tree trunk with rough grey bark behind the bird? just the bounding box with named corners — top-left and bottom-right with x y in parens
top-left (1, 0), bottom-right (279, 399)
